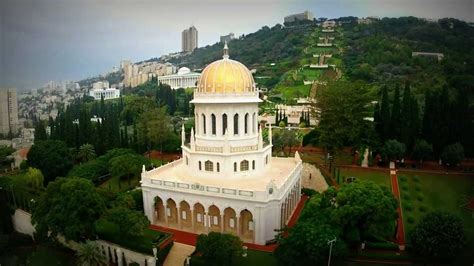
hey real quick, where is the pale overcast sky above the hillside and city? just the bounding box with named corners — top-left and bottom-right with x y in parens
top-left (0, 0), bottom-right (474, 89)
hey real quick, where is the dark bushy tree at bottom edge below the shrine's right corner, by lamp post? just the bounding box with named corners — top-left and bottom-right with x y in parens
top-left (275, 221), bottom-right (347, 265)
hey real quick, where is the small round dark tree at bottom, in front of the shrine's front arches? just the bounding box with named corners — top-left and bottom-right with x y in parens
top-left (196, 232), bottom-right (242, 265)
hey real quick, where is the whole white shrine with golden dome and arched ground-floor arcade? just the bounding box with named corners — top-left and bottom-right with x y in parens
top-left (141, 46), bottom-right (302, 245)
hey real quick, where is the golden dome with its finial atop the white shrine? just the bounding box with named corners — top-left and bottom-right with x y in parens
top-left (197, 43), bottom-right (255, 93)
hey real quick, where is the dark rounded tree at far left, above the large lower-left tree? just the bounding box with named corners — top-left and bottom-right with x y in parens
top-left (27, 140), bottom-right (72, 185)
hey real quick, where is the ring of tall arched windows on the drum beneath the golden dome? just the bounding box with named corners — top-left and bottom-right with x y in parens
top-left (196, 112), bottom-right (258, 136)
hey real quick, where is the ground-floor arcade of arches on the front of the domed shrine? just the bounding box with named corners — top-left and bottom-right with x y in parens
top-left (153, 197), bottom-right (255, 243)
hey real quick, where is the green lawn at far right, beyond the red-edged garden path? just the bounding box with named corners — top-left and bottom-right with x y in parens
top-left (398, 171), bottom-right (474, 240)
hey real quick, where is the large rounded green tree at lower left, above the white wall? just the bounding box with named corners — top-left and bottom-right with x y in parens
top-left (31, 177), bottom-right (105, 241)
